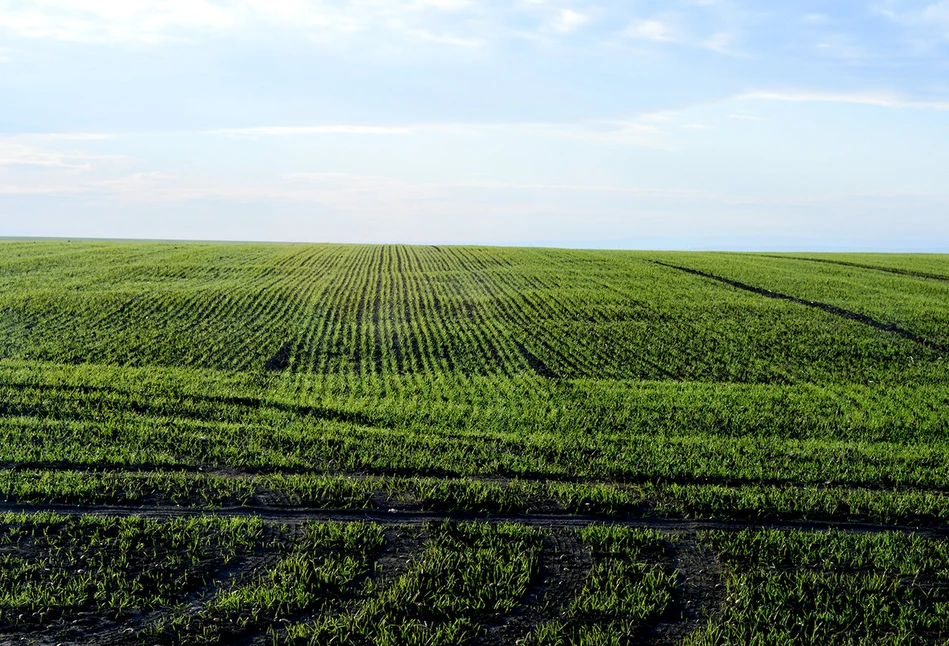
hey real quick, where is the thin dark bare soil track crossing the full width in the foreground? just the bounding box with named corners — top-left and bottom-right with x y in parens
top-left (0, 503), bottom-right (949, 540)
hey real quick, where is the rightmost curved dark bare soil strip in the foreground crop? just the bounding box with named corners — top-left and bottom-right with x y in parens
top-left (647, 540), bottom-right (725, 645)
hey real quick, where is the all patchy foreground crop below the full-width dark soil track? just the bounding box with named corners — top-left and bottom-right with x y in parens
top-left (0, 514), bottom-right (949, 645)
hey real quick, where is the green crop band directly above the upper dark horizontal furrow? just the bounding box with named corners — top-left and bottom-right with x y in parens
top-left (7, 408), bottom-right (949, 490)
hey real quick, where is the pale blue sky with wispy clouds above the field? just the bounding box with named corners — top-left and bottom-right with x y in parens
top-left (0, 0), bottom-right (949, 252)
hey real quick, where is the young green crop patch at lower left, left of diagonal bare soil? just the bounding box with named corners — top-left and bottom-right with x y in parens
top-left (0, 514), bottom-right (262, 621)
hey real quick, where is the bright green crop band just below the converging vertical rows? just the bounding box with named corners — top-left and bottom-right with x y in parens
top-left (0, 361), bottom-right (949, 443)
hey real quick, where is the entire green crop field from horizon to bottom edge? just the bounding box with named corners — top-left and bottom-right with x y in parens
top-left (0, 240), bottom-right (949, 646)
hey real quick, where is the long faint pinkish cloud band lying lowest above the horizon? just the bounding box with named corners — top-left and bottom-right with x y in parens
top-left (7, 172), bottom-right (949, 217)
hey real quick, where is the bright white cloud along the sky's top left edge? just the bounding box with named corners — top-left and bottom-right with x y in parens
top-left (0, 0), bottom-right (572, 51)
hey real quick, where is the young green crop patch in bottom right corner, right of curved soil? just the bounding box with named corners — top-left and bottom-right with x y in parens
top-left (686, 531), bottom-right (949, 646)
